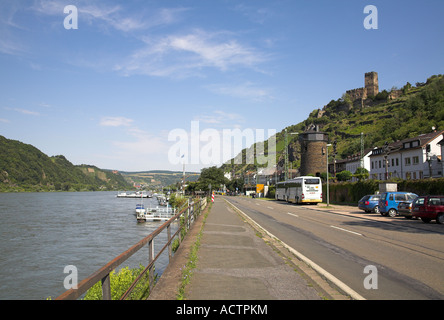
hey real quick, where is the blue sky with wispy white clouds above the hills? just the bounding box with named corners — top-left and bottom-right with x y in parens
top-left (0, 0), bottom-right (444, 171)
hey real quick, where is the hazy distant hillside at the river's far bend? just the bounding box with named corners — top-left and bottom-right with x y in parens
top-left (120, 170), bottom-right (200, 187)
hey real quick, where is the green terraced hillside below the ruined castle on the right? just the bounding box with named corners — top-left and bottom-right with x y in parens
top-left (222, 75), bottom-right (444, 174)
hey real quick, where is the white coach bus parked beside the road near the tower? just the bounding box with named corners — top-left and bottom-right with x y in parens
top-left (275, 177), bottom-right (322, 203)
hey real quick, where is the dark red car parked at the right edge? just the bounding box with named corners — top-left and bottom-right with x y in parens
top-left (412, 196), bottom-right (444, 224)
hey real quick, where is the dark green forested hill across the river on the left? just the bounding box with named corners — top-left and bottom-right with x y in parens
top-left (0, 136), bottom-right (132, 192)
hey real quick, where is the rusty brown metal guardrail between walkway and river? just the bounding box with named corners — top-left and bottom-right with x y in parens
top-left (56, 198), bottom-right (207, 300)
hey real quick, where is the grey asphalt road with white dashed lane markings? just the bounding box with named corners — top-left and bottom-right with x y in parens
top-left (224, 197), bottom-right (444, 300)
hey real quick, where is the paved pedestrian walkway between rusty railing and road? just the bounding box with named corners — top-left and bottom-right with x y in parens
top-left (185, 197), bottom-right (323, 300)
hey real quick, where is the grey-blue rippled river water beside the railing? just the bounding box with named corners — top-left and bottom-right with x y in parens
top-left (0, 192), bottom-right (176, 299)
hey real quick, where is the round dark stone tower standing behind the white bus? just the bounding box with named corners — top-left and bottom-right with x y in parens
top-left (299, 131), bottom-right (328, 176)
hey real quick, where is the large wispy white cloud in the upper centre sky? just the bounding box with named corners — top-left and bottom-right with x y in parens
top-left (115, 30), bottom-right (266, 78)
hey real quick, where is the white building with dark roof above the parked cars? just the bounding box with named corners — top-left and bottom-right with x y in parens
top-left (370, 130), bottom-right (444, 180)
